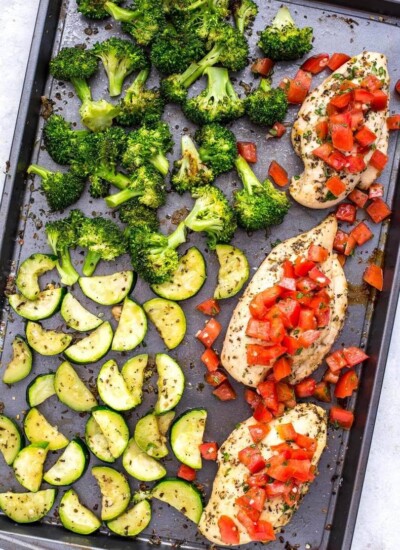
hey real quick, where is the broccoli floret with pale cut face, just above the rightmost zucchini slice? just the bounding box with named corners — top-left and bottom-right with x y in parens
top-left (184, 185), bottom-right (236, 250)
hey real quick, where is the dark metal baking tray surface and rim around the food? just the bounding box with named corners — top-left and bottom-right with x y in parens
top-left (0, 0), bottom-right (400, 550)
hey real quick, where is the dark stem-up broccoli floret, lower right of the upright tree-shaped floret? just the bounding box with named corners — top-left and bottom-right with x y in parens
top-left (117, 69), bottom-right (165, 126)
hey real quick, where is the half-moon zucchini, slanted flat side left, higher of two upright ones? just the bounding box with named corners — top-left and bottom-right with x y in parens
top-left (111, 298), bottom-right (147, 351)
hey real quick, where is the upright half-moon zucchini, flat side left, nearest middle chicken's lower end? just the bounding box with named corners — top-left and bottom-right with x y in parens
top-left (154, 353), bottom-right (185, 414)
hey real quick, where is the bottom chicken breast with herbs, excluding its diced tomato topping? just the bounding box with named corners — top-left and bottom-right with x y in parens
top-left (199, 403), bottom-right (327, 546)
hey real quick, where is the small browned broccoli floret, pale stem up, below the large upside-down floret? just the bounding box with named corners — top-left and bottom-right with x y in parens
top-left (171, 135), bottom-right (214, 193)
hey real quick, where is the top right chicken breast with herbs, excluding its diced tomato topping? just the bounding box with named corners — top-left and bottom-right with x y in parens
top-left (289, 52), bottom-right (389, 208)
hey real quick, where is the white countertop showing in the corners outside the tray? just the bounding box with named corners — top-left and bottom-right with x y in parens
top-left (0, 0), bottom-right (400, 550)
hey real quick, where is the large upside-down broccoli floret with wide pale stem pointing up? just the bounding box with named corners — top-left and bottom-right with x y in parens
top-left (183, 67), bottom-right (244, 124)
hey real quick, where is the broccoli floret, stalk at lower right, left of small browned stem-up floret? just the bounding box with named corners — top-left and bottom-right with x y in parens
top-left (122, 122), bottom-right (173, 176)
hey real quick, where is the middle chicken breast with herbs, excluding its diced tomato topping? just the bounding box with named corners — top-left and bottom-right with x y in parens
top-left (221, 215), bottom-right (347, 387)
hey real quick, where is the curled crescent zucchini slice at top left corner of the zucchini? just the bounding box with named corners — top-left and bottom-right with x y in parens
top-left (15, 254), bottom-right (57, 300)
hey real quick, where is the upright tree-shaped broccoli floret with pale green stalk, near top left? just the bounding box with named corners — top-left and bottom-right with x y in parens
top-left (93, 36), bottom-right (148, 97)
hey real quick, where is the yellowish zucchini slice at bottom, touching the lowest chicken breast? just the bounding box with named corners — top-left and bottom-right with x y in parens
top-left (151, 477), bottom-right (203, 523)
